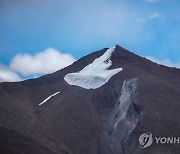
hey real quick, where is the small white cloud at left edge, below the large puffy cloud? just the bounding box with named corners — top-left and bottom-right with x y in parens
top-left (0, 64), bottom-right (22, 82)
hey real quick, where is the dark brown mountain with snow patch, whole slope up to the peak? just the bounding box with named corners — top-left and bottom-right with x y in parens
top-left (0, 46), bottom-right (180, 154)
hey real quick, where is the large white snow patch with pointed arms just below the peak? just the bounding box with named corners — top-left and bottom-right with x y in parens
top-left (64, 47), bottom-right (122, 89)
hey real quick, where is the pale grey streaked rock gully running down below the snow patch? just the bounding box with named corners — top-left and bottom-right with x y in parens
top-left (101, 79), bottom-right (141, 154)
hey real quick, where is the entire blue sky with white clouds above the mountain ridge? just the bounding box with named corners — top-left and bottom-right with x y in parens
top-left (0, 0), bottom-right (180, 82)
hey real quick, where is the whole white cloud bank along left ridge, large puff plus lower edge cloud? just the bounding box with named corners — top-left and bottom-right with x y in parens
top-left (0, 48), bottom-right (75, 82)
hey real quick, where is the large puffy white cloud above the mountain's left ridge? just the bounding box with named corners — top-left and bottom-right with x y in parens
top-left (10, 48), bottom-right (75, 76)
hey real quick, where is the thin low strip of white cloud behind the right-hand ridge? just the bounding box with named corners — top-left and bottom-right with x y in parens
top-left (145, 56), bottom-right (180, 69)
